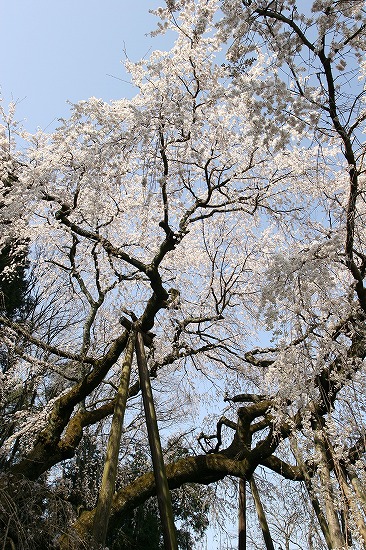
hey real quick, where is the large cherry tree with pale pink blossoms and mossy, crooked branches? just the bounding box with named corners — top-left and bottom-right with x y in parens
top-left (0, 0), bottom-right (366, 549)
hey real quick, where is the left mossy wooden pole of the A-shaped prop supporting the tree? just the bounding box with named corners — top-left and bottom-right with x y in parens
top-left (93, 332), bottom-right (136, 548)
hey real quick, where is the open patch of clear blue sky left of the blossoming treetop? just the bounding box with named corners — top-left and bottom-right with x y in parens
top-left (0, 0), bottom-right (170, 132)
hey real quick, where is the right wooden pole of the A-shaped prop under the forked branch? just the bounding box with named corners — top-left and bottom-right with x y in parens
top-left (136, 332), bottom-right (178, 550)
